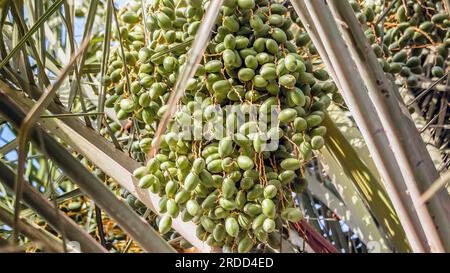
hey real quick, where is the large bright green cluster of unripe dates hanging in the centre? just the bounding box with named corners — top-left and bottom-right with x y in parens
top-left (102, 0), bottom-right (337, 252)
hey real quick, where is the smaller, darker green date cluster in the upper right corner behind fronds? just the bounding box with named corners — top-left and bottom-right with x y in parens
top-left (350, 0), bottom-right (450, 87)
